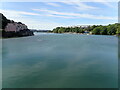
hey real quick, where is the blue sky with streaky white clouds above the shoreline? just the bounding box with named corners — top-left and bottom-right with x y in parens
top-left (0, 0), bottom-right (118, 30)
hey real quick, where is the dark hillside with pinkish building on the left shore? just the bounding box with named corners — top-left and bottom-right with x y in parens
top-left (0, 13), bottom-right (34, 38)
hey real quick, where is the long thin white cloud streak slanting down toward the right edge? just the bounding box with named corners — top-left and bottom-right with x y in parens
top-left (32, 9), bottom-right (117, 20)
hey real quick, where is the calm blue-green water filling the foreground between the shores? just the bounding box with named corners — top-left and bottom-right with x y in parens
top-left (2, 34), bottom-right (118, 88)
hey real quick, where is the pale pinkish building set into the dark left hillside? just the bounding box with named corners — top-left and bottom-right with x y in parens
top-left (5, 22), bottom-right (28, 32)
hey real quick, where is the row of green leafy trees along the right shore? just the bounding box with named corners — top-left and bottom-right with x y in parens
top-left (53, 23), bottom-right (120, 35)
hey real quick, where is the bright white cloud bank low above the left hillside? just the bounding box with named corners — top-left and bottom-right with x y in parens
top-left (0, 9), bottom-right (62, 30)
